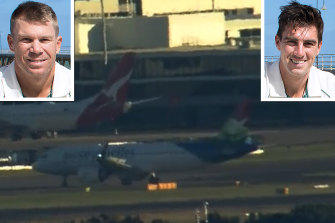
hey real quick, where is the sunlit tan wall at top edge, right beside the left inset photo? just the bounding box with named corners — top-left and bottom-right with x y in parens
top-left (74, 0), bottom-right (119, 15)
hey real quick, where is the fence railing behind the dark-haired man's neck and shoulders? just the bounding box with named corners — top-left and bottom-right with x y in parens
top-left (264, 54), bottom-right (335, 71)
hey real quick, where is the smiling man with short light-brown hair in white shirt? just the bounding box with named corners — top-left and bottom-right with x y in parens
top-left (0, 1), bottom-right (72, 99)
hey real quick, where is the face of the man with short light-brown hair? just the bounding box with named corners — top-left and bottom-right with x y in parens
top-left (7, 17), bottom-right (62, 79)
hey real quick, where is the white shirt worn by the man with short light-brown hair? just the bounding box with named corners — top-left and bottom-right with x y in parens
top-left (0, 61), bottom-right (73, 100)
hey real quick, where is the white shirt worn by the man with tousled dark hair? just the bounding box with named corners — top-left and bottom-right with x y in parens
top-left (262, 60), bottom-right (335, 99)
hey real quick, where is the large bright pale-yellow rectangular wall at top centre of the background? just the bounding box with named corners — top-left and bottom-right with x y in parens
top-left (169, 12), bottom-right (225, 47)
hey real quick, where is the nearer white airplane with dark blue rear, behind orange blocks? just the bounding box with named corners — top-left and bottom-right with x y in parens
top-left (32, 100), bottom-right (258, 187)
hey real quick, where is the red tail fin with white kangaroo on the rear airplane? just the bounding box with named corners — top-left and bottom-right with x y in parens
top-left (77, 53), bottom-right (135, 127)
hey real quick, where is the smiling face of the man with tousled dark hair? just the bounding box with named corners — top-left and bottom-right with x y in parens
top-left (275, 26), bottom-right (322, 77)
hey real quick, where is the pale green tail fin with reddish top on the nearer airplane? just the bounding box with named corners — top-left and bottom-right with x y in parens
top-left (218, 99), bottom-right (251, 141)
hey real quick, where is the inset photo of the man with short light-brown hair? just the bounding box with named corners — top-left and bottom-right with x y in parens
top-left (0, 0), bottom-right (74, 101)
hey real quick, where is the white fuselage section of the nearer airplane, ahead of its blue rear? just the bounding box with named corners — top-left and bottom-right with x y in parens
top-left (34, 142), bottom-right (204, 174)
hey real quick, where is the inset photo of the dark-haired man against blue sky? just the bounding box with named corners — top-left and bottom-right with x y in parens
top-left (261, 0), bottom-right (335, 101)
